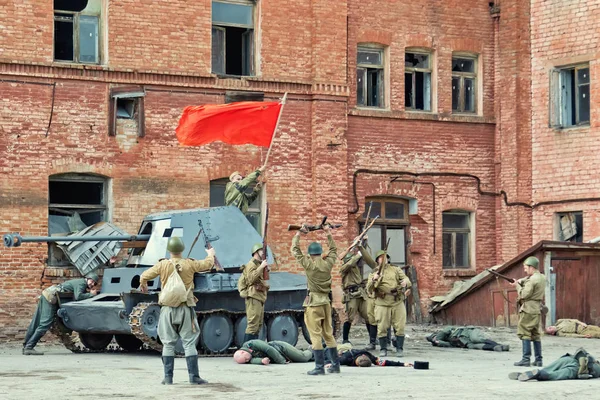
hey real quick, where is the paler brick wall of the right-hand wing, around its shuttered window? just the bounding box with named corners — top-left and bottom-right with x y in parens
top-left (531, 0), bottom-right (600, 240)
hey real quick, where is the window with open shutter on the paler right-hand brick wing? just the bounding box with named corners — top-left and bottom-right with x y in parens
top-left (550, 64), bottom-right (590, 128)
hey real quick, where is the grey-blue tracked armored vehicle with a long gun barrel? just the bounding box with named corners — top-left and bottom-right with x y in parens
top-left (4, 206), bottom-right (339, 354)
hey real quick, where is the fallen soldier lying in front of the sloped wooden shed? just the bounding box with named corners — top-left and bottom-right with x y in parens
top-left (426, 326), bottom-right (509, 351)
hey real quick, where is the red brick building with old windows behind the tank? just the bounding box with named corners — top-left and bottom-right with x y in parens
top-left (0, 0), bottom-right (600, 338)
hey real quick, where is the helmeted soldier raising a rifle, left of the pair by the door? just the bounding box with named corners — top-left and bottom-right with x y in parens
top-left (340, 248), bottom-right (372, 343)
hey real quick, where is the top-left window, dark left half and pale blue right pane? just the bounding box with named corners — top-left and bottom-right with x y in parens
top-left (54, 0), bottom-right (102, 64)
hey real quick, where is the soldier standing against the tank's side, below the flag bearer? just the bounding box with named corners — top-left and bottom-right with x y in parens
top-left (242, 243), bottom-right (269, 342)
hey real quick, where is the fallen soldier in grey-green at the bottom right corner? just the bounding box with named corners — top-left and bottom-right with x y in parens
top-left (508, 347), bottom-right (600, 382)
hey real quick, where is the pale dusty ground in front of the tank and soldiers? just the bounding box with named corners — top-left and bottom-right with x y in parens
top-left (0, 326), bottom-right (600, 400)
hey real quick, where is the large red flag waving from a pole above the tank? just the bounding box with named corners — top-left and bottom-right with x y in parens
top-left (175, 101), bottom-right (282, 147)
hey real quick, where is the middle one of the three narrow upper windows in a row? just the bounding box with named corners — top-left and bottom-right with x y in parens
top-left (404, 52), bottom-right (431, 111)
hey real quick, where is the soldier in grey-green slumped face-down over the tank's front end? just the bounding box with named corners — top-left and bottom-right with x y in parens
top-left (23, 272), bottom-right (99, 356)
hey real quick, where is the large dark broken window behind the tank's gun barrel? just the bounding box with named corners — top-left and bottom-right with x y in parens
top-left (48, 174), bottom-right (108, 265)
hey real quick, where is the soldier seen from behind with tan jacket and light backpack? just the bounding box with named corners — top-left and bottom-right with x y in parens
top-left (140, 237), bottom-right (215, 385)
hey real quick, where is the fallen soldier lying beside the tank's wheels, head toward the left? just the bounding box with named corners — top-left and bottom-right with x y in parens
top-left (233, 339), bottom-right (313, 365)
